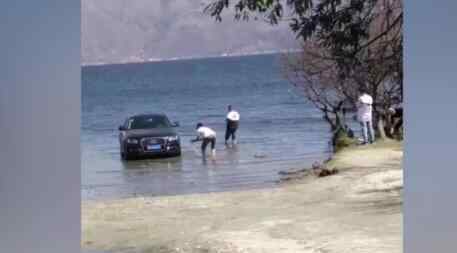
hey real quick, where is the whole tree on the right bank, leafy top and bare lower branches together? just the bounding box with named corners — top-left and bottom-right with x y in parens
top-left (205, 0), bottom-right (403, 138)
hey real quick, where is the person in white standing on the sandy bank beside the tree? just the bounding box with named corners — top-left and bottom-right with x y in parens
top-left (357, 89), bottom-right (375, 144)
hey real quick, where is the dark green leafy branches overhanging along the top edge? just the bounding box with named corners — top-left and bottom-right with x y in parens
top-left (205, 0), bottom-right (403, 64)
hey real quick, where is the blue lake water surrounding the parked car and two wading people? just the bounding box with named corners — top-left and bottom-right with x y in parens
top-left (81, 55), bottom-right (330, 199)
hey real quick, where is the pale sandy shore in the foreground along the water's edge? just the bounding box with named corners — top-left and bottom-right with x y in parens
top-left (82, 142), bottom-right (403, 253)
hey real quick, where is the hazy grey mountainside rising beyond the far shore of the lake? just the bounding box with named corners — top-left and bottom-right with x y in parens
top-left (81, 0), bottom-right (296, 64)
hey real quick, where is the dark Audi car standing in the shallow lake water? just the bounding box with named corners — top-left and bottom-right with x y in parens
top-left (119, 114), bottom-right (181, 160)
